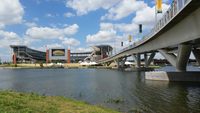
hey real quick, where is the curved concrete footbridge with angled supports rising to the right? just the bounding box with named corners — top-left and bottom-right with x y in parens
top-left (97, 0), bottom-right (200, 81)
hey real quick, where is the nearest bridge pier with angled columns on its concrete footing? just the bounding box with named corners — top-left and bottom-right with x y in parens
top-left (145, 44), bottom-right (200, 82)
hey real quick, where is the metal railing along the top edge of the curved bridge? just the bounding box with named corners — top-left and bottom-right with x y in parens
top-left (107, 0), bottom-right (192, 60)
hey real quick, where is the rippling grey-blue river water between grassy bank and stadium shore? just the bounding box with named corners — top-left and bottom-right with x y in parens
top-left (0, 66), bottom-right (200, 113)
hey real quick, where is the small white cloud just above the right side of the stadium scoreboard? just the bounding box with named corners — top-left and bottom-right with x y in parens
top-left (62, 38), bottom-right (80, 46)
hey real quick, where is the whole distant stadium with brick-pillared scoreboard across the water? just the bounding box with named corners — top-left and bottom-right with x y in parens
top-left (10, 45), bottom-right (113, 64)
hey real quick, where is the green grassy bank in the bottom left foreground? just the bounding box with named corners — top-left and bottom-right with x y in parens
top-left (0, 91), bottom-right (118, 113)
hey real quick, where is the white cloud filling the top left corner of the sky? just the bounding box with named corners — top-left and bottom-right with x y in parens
top-left (0, 0), bottom-right (24, 27)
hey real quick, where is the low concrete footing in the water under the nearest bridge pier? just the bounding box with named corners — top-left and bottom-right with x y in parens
top-left (145, 71), bottom-right (200, 82)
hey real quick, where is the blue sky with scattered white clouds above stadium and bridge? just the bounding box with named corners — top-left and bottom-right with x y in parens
top-left (0, 0), bottom-right (171, 61)
